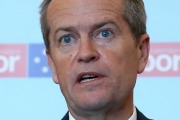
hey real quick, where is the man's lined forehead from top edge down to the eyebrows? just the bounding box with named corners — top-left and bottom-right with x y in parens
top-left (47, 0), bottom-right (124, 32)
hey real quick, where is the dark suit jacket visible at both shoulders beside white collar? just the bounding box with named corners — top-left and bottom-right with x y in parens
top-left (61, 109), bottom-right (150, 120)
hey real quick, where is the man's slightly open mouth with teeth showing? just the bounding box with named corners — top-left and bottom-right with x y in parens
top-left (78, 73), bottom-right (102, 83)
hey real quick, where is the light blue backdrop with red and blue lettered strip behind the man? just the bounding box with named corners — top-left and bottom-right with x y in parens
top-left (0, 0), bottom-right (180, 120)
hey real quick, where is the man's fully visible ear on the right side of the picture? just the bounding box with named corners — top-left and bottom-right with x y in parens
top-left (137, 34), bottom-right (150, 74)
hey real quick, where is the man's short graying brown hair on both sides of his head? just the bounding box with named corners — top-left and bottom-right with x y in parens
top-left (40, 0), bottom-right (146, 50)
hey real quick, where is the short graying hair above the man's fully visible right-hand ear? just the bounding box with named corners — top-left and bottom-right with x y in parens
top-left (123, 0), bottom-right (147, 43)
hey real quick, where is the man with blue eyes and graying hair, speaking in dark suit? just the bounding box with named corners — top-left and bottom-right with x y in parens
top-left (41, 0), bottom-right (149, 120)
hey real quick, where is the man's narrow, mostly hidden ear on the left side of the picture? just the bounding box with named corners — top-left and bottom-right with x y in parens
top-left (46, 50), bottom-right (59, 84)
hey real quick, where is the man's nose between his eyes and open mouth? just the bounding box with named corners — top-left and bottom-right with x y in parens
top-left (77, 40), bottom-right (100, 63)
